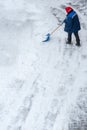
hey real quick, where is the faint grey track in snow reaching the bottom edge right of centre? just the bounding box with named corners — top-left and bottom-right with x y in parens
top-left (43, 89), bottom-right (67, 130)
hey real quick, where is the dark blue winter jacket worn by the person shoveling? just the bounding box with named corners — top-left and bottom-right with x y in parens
top-left (64, 10), bottom-right (81, 33)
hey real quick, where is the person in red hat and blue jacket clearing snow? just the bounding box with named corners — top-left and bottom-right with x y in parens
top-left (64, 6), bottom-right (81, 46)
